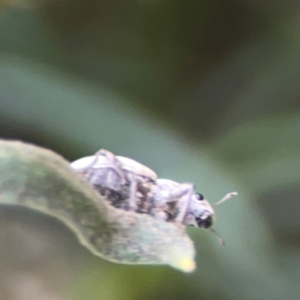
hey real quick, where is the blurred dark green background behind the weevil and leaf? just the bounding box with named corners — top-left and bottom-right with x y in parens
top-left (0, 0), bottom-right (300, 300)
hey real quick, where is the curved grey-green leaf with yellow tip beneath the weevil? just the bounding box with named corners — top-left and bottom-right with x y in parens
top-left (0, 141), bottom-right (195, 272)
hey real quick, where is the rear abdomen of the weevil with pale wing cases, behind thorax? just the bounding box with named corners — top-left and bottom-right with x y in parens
top-left (71, 150), bottom-right (157, 213)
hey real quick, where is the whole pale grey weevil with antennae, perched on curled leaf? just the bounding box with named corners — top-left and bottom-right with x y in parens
top-left (71, 149), bottom-right (237, 243)
